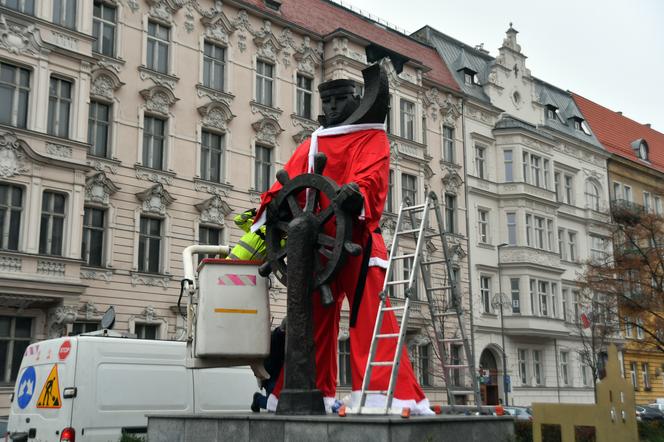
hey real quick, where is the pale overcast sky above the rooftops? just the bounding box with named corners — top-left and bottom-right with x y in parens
top-left (343, 0), bottom-right (664, 132)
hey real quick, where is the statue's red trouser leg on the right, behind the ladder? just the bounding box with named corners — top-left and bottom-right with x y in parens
top-left (348, 267), bottom-right (425, 401)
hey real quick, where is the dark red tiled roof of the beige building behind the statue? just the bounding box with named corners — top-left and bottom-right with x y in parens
top-left (238, 0), bottom-right (460, 91)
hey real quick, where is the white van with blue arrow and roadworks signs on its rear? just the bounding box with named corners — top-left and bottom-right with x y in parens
top-left (8, 335), bottom-right (257, 442)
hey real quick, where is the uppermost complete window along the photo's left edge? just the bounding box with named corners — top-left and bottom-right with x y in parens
top-left (0, 63), bottom-right (30, 128)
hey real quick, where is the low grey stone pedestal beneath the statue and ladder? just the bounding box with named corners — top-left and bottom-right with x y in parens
top-left (148, 413), bottom-right (514, 442)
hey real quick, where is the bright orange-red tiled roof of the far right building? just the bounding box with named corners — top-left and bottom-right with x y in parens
top-left (572, 92), bottom-right (664, 172)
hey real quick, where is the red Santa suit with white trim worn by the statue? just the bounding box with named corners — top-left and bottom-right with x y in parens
top-left (252, 124), bottom-right (431, 414)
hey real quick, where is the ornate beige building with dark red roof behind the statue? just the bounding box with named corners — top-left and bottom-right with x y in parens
top-left (0, 0), bottom-right (469, 414)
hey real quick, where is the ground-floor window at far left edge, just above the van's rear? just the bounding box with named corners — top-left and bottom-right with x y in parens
top-left (0, 316), bottom-right (36, 387)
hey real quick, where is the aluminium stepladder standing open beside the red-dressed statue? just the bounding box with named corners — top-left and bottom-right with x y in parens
top-left (347, 192), bottom-right (481, 414)
